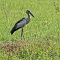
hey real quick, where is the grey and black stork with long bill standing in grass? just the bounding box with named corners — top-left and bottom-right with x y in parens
top-left (10, 10), bottom-right (34, 40)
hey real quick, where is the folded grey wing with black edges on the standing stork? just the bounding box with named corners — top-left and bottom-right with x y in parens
top-left (11, 18), bottom-right (26, 34)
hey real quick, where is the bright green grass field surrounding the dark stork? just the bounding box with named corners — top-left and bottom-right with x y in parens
top-left (0, 0), bottom-right (60, 60)
